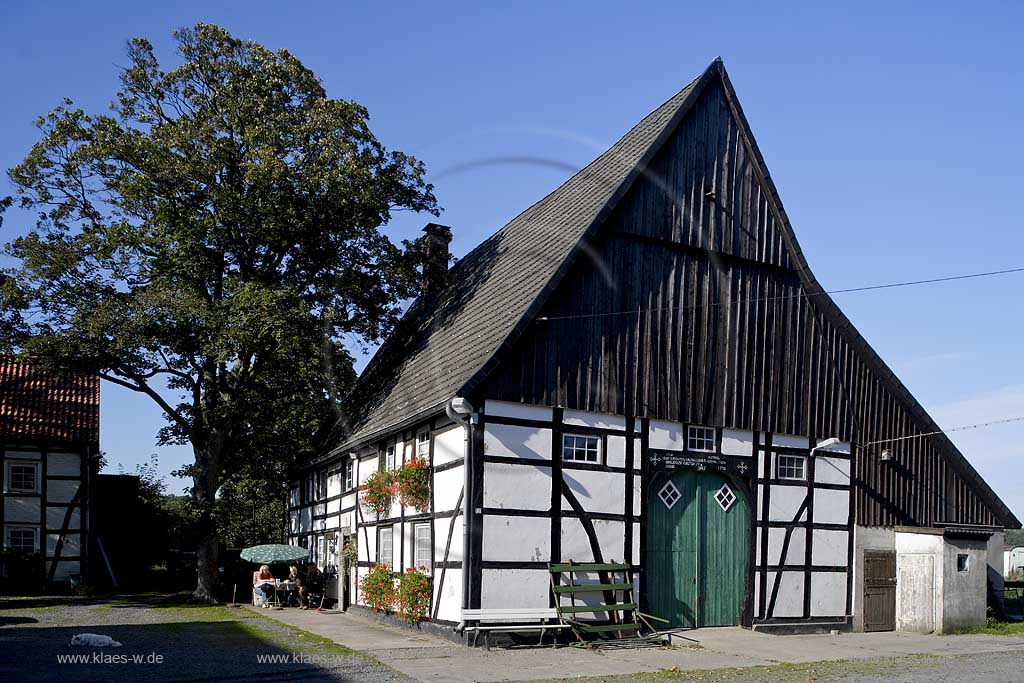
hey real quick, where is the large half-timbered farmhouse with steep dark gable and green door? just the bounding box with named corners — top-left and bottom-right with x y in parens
top-left (289, 60), bottom-right (1020, 631)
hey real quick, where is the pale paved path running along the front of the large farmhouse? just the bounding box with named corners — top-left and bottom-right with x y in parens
top-left (245, 609), bottom-right (1024, 683)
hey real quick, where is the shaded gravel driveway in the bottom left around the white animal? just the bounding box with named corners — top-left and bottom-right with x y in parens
top-left (0, 598), bottom-right (409, 683)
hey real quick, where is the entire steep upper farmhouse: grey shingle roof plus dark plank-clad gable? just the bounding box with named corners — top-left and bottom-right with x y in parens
top-left (325, 60), bottom-right (1019, 526)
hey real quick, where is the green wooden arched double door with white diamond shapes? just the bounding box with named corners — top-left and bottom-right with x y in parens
top-left (644, 470), bottom-right (750, 628)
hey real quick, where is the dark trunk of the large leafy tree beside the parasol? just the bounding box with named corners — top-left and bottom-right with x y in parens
top-left (191, 430), bottom-right (224, 603)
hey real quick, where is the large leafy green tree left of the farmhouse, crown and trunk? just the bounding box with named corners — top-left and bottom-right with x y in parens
top-left (0, 24), bottom-right (437, 600)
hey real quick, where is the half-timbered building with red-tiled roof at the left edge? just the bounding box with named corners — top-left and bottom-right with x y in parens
top-left (0, 356), bottom-right (99, 583)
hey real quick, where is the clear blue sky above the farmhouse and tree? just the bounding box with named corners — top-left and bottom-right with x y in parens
top-left (0, 0), bottom-right (1024, 515)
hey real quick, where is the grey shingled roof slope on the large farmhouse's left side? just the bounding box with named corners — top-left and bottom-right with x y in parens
top-left (333, 60), bottom-right (718, 452)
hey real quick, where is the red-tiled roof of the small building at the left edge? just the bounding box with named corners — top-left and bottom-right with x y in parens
top-left (0, 357), bottom-right (99, 444)
